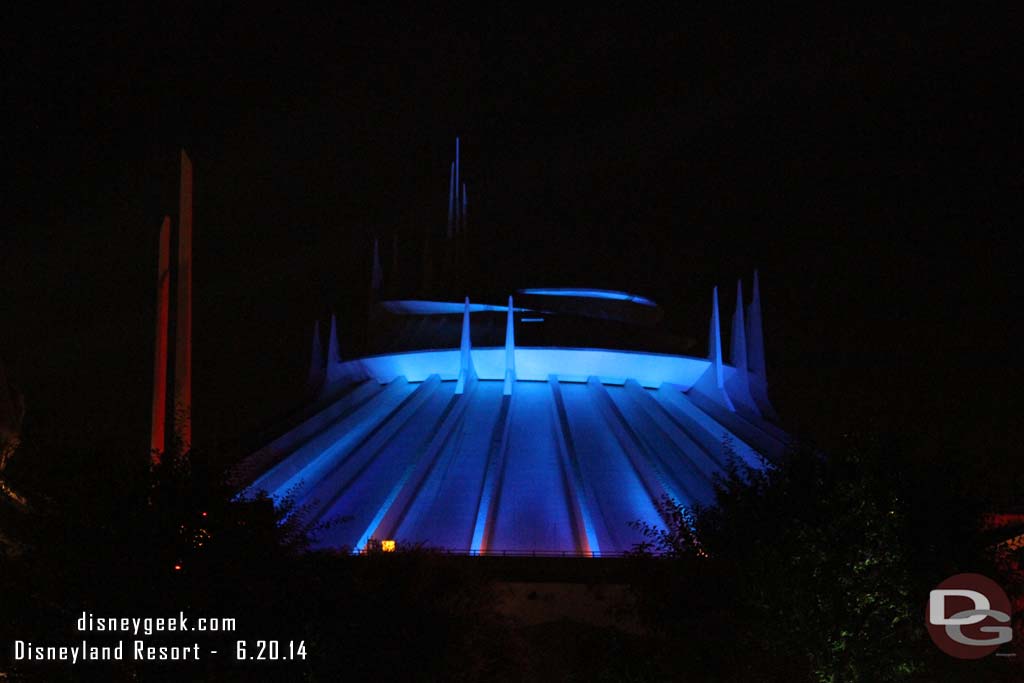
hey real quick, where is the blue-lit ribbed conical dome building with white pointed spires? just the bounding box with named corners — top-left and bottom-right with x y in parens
top-left (234, 140), bottom-right (786, 556)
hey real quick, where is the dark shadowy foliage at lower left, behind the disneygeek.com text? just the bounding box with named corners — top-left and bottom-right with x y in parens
top-left (0, 440), bottom-right (516, 681)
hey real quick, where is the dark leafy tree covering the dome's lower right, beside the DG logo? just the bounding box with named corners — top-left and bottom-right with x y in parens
top-left (633, 435), bottom-right (1017, 682)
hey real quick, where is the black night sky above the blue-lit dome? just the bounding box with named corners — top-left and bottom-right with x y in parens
top-left (0, 4), bottom-right (1024, 473)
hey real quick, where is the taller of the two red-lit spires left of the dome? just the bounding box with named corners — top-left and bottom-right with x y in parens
top-left (174, 150), bottom-right (193, 454)
